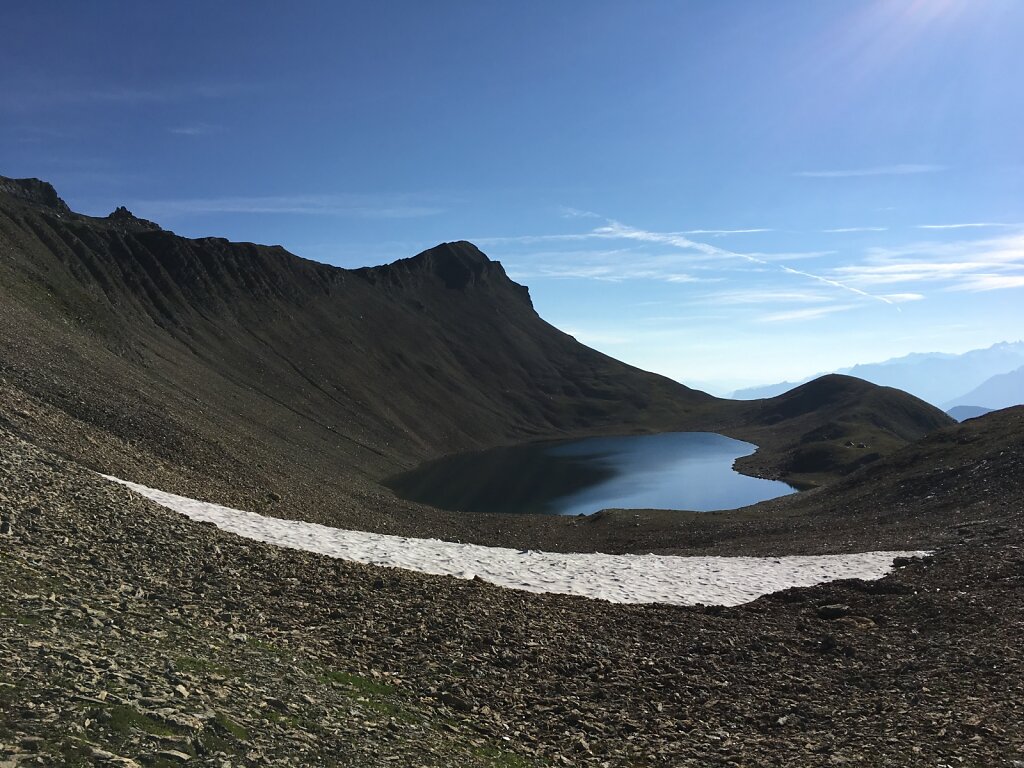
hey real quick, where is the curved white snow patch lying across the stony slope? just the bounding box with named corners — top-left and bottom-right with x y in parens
top-left (103, 475), bottom-right (928, 605)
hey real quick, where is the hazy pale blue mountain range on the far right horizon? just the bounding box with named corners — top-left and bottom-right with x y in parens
top-left (732, 341), bottom-right (1024, 410)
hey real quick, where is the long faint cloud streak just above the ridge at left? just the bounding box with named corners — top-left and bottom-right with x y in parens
top-left (132, 195), bottom-right (444, 219)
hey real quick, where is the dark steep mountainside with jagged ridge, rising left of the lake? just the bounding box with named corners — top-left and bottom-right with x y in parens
top-left (0, 176), bottom-right (711, 499)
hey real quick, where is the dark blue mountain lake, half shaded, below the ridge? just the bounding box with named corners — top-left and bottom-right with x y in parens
top-left (386, 432), bottom-right (794, 515)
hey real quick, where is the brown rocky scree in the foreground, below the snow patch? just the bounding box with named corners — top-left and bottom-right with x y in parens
top-left (0, 400), bottom-right (1024, 768)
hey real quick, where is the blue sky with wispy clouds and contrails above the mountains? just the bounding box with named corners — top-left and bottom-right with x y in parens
top-left (0, 0), bottom-right (1024, 393)
